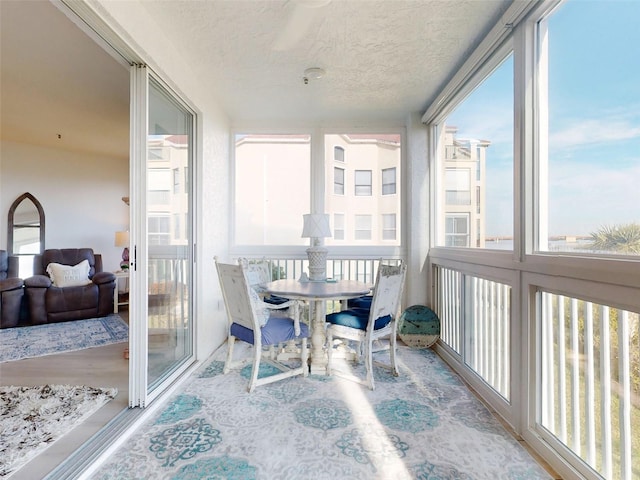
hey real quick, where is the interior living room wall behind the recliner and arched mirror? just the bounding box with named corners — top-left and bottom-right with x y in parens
top-left (0, 140), bottom-right (129, 271)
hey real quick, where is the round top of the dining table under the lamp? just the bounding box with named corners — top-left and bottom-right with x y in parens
top-left (263, 278), bottom-right (371, 300)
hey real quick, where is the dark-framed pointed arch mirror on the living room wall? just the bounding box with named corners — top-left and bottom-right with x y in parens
top-left (7, 193), bottom-right (44, 278)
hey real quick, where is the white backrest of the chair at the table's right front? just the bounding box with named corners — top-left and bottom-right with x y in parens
top-left (367, 264), bottom-right (407, 330)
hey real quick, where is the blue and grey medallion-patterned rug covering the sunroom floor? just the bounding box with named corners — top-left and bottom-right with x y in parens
top-left (91, 347), bottom-right (551, 480)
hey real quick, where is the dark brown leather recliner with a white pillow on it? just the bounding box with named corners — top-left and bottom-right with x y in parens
top-left (24, 248), bottom-right (116, 325)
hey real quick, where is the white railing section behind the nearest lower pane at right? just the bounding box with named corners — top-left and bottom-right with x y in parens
top-left (538, 290), bottom-right (640, 479)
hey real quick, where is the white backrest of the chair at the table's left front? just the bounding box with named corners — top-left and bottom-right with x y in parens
top-left (216, 259), bottom-right (260, 331)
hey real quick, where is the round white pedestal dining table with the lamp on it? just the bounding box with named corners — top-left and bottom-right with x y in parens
top-left (264, 279), bottom-right (372, 375)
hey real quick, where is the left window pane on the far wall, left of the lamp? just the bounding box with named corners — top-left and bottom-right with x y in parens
top-left (235, 135), bottom-right (311, 245)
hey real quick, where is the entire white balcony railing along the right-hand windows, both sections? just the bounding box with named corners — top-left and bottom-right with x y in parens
top-left (431, 255), bottom-right (640, 480)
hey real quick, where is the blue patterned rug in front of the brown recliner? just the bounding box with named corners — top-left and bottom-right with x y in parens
top-left (0, 313), bottom-right (129, 362)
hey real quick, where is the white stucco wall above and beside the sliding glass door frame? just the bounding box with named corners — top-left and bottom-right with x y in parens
top-left (87, 0), bottom-right (230, 358)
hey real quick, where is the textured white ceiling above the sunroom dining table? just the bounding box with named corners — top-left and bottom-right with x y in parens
top-left (144, 0), bottom-right (511, 121)
